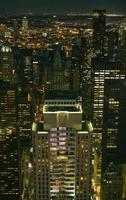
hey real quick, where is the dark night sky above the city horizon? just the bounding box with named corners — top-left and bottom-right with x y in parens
top-left (0, 0), bottom-right (126, 14)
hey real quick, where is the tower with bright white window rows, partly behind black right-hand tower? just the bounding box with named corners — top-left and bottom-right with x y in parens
top-left (92, 59), bottom-right (126, 198)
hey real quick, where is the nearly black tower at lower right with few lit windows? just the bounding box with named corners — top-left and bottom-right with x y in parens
top-left (101, 80), bottom-right (126, 200)
